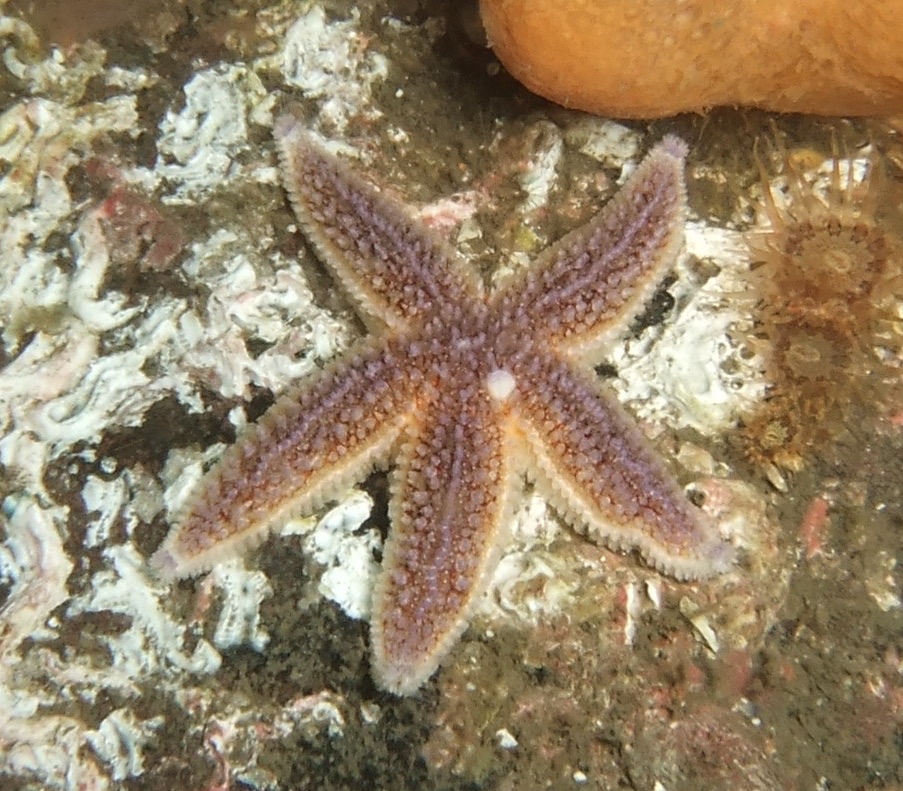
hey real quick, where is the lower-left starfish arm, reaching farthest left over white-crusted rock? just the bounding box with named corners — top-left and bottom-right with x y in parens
top-left (152, 338), bottom-right (418, 577)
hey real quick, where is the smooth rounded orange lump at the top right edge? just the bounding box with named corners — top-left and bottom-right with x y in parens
top-left (480, 0), bottom-right (903, 118)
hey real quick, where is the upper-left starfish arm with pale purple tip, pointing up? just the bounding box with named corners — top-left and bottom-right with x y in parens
top-left (275, 115), bottom-right (482, 330)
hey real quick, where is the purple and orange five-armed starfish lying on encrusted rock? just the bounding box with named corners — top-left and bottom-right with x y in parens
top-left (153, 116), bottom-right (731, 694)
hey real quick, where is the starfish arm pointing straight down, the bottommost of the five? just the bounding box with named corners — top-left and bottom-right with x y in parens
top-left (370, 388), bottom-right (511, 695)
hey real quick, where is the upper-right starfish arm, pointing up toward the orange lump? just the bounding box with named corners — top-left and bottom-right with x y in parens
top-left (495, 136), bottom-right (687, 355)
